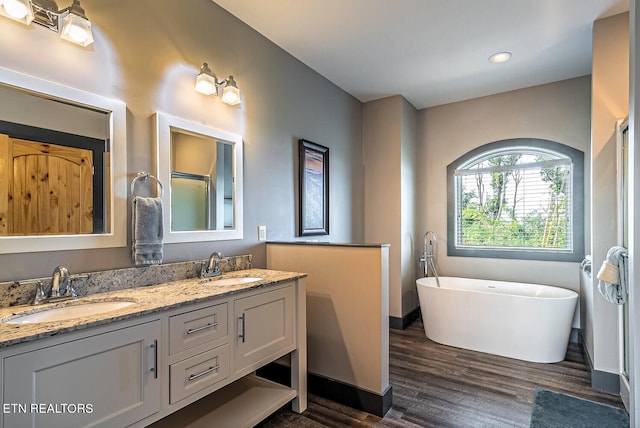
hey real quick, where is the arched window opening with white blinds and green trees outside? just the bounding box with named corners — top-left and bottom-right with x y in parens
top-left (456, 151), bottom-right (571, 249)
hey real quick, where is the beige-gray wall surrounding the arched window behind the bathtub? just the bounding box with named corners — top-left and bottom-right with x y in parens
top-left (417, 76), bottom-right (591, 327)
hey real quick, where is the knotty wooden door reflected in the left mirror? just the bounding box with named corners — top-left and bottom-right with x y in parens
top-left (0, 134), bottom-right (93, 235)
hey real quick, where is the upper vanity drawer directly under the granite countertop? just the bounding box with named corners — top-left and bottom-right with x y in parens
top-left (169, 303), bottom-right (229, 355)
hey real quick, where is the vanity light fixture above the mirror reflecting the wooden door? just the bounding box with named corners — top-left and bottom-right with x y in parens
top-left (0, 0), bottom-right (93, 47)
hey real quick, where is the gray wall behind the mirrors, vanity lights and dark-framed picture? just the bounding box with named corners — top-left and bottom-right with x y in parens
top-left (0, 0), bottom-right (364, 280)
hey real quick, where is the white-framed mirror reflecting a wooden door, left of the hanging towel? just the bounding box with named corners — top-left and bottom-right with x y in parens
top-left (0, 68), bottom-right (127, 254)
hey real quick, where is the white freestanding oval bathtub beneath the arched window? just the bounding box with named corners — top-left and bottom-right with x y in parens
top-left (416, 277), bottom-right (578, 363)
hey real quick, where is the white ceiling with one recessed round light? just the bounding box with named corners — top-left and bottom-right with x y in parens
top-left (213, 0), bottom-right (629, 109)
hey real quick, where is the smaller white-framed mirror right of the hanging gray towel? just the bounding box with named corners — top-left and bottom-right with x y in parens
top-left (155, 113), bottom-right (243, 243)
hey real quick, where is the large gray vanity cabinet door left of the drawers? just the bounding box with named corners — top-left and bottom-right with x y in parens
top-left (2, 321), bottom-right (160, 428)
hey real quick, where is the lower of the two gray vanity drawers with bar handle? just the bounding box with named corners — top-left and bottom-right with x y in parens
top-left (169, 344), bottom-right (229, 404)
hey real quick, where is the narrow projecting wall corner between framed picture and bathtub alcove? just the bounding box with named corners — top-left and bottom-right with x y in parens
top-left (363, 95), bottom-right (418, 318)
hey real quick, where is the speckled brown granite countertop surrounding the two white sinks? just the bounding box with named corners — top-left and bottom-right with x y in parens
top-left (0, 269), bottom-right (306, 348)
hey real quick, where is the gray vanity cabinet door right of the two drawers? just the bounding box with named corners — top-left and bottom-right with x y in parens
top-left (234, 287), bottom-right (295, 373)
